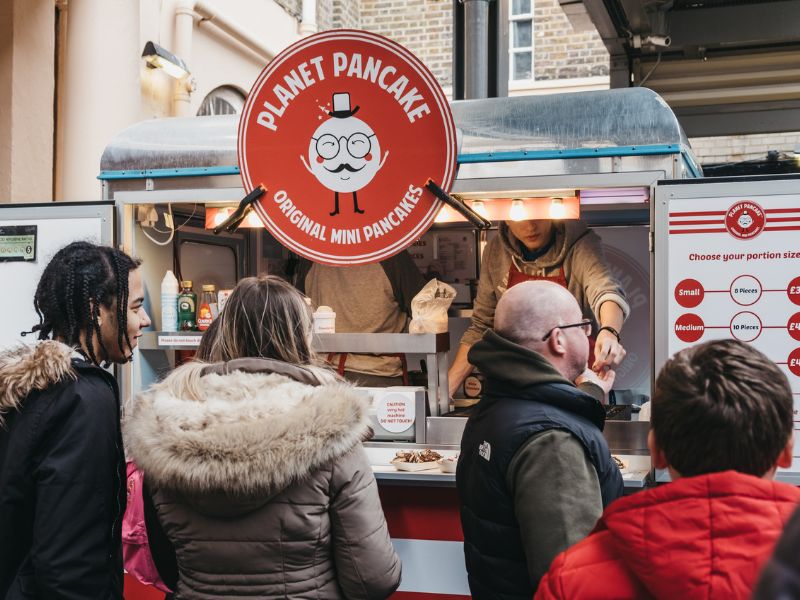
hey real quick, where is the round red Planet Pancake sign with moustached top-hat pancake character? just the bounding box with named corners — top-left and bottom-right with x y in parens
top-left (238, 29), bottom-right (456, 265)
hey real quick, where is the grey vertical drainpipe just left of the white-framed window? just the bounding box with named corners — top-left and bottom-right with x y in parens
top-left (462, 0), bottom-right (491, 99)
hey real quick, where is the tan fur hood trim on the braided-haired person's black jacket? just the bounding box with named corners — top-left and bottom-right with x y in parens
top-left (0, 340), bottom-right (76, 424)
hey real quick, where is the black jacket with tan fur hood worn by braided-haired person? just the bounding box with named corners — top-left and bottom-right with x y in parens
top-left (0, 341), bottom-right (126, 600)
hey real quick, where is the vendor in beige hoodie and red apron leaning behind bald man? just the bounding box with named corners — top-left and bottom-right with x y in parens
top-left (448, 220), bottom-right (630, 396)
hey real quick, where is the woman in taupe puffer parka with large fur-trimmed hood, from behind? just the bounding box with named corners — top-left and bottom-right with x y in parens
top-left (124, 276), bottom-right (400, 600)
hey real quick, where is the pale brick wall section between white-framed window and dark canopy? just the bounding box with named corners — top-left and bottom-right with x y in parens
top-left (536, 0), bottom-right (609, 80)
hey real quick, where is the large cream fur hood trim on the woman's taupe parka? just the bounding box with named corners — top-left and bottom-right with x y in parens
top-left (123, 363), bottom-right (369, 499)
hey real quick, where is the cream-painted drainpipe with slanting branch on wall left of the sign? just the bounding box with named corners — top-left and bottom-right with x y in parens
top-left (172, 0), bottom-right (278, 117)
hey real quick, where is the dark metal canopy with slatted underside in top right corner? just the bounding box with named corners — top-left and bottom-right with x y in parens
top-left (559, 0), bottom-right (800, 137)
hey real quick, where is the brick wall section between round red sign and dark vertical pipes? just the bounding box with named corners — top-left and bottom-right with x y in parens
top-left (359, 0), bottom-right (453, 97)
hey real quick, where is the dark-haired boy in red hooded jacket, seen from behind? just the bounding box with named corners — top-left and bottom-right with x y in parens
top-left (536, 340), bottom-right (800, 600)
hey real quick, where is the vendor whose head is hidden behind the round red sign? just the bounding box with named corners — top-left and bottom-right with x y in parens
top-left (297, 250), bottom-right (425, 387)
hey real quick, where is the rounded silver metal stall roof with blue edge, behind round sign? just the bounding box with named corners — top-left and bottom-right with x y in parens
top-left (100, 88), bottom-right (693, 179)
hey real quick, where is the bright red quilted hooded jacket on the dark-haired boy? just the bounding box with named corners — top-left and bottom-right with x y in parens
top-left (536, 471), bottom-right (800, 600)
